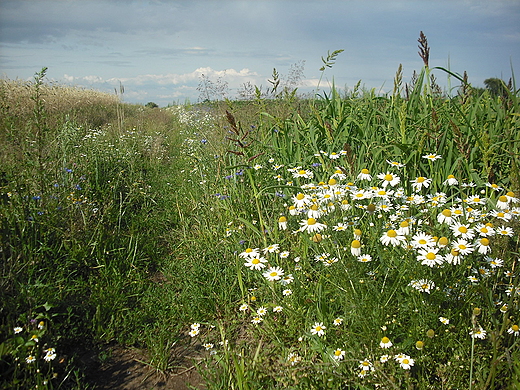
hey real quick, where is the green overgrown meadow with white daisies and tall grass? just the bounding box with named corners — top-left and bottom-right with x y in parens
top-left (0, 52), bottom-right (520, 389)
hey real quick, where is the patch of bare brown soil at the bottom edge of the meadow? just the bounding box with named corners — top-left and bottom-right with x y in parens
top-left (80, 346), bottom-right (206, 390)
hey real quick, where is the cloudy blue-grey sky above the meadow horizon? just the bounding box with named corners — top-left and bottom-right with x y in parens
top-left (0, 0), bottom-right (520, 106)
